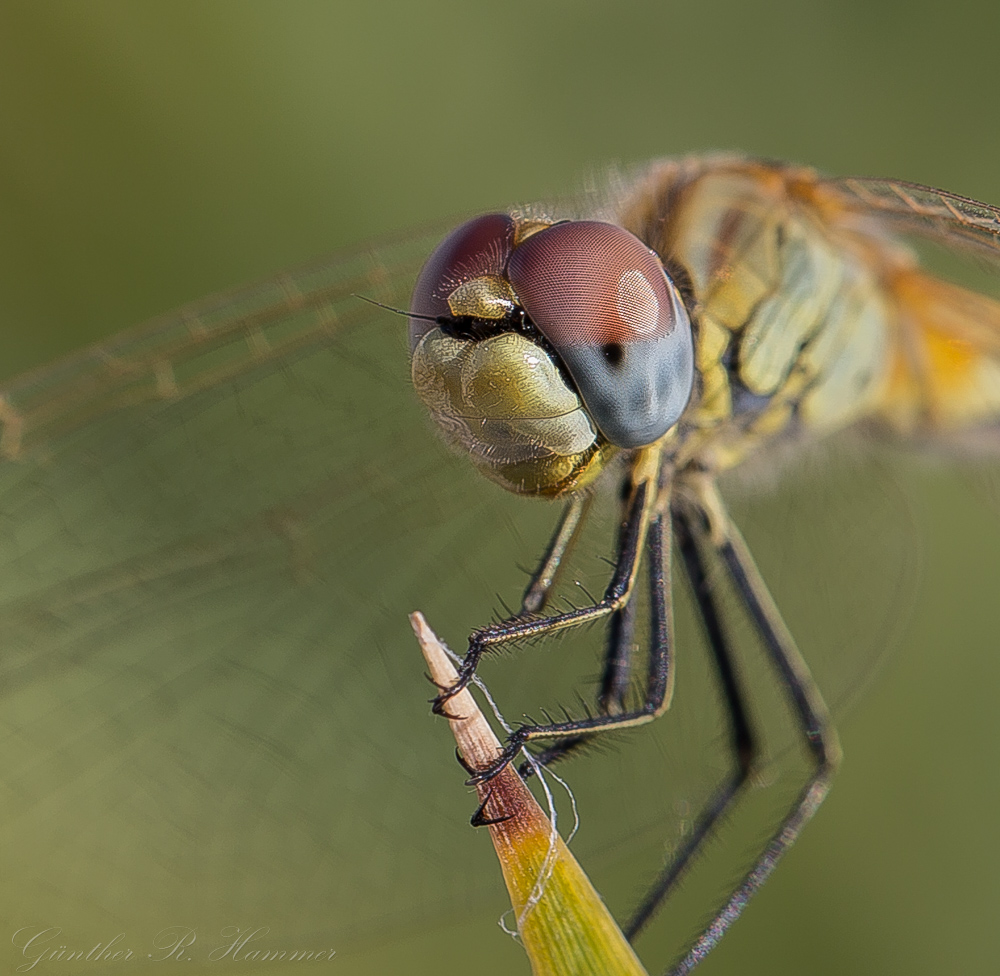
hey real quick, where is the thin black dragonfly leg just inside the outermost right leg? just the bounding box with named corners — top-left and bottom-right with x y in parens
top-left (623, 510), bottom-right (757, 939)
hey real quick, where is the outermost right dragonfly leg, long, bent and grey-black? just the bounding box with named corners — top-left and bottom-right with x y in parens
top-left (669, 483), bottom-right (841, 976)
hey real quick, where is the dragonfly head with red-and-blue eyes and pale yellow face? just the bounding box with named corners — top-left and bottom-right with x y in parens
top-left (410, 214), bottom-right (694, 496)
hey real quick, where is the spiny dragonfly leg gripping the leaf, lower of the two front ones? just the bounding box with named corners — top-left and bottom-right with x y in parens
top-left (468, 512), bottom-right (673, 784)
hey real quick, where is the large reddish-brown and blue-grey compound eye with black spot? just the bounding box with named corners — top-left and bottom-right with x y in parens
top-left (507, 220), bottom-right (694, 447)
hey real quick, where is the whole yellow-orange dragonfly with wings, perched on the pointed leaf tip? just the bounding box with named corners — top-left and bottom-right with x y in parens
top-left (0, 156), bottom-right (1000, 973)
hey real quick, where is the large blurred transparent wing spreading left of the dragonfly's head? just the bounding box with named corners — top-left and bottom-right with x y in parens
top-left (0, 232), bottom-right (564, 966)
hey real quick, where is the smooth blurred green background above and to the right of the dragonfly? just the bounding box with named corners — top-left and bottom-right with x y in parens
top-left (0, 0), bottom-right (1000, 976)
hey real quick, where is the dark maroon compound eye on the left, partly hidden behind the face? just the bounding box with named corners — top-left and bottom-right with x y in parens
top-left (410, 214), bottom-right (514, 352)
